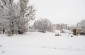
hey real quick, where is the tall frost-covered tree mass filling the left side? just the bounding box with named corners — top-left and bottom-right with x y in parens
top-left (0, 0), bottom-right (35, 35)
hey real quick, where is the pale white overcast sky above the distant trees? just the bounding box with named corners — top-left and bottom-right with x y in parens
top-left (29, 0), bottom-right (85, 25)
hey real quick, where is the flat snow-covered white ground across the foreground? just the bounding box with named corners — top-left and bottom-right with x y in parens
top-left (0, 32), bottom-right (85, 55)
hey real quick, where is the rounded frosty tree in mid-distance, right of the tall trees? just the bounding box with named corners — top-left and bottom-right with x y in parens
top-left (34, 19), bottom-right (52, 32)
